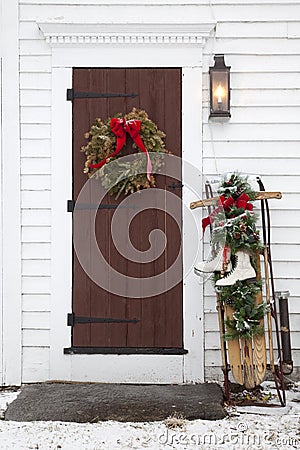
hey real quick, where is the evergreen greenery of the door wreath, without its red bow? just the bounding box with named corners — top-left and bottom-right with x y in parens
top-left (81, 108), bottom-right (170, 199)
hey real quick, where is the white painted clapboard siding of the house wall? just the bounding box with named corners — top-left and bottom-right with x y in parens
top-left (3, 0), bottom-right (300, 382)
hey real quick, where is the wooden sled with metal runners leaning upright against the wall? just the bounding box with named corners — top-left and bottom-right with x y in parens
top-left (190, 177), bottom-right (286, 406)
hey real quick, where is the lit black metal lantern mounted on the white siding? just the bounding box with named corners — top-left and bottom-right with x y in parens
top-left (209, 55), bottom-right (230, 117)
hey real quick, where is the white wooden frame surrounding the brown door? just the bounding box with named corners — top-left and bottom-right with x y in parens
top-left (44, 23), bottom-right (212, 383)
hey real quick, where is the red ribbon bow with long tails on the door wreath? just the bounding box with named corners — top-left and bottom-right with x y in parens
top-left (90, 117), bottom-right (152, 181)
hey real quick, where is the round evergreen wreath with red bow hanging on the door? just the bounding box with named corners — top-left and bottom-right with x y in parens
top-left (81, 108), bottom-right (170, 199)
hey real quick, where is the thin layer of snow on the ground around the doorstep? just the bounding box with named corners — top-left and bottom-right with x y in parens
top-left (0, 383), bottom-right (300, 450)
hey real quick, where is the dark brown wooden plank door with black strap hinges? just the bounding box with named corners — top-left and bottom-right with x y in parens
top-left (72, 68), bottom-right (183, 352)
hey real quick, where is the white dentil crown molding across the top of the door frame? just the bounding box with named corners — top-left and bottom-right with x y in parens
top-left (38, 22), bottom-right (215, 47)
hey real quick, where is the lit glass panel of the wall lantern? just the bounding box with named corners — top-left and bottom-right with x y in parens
top-left (211, 70), bottom-right (229, 113)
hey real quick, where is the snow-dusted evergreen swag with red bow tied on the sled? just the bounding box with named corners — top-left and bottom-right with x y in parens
top-left (203, 173), bottom-right (268, 340)
